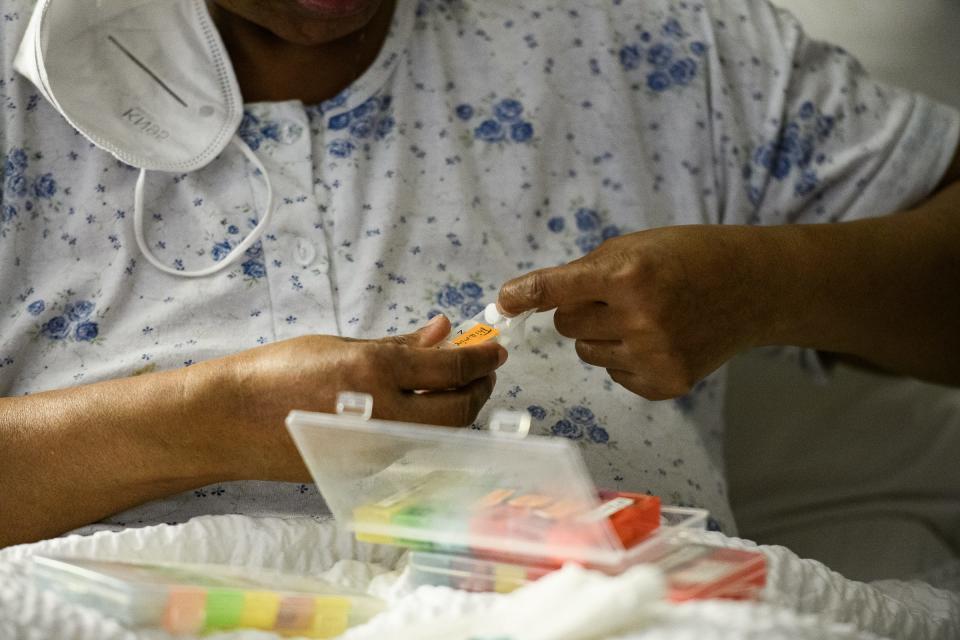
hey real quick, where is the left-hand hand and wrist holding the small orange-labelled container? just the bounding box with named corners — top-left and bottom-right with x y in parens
top-left (188, 316), bottom-right (507, 481)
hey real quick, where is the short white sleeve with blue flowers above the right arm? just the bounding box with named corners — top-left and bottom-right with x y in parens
top-left (708, 0), bottom-right (960, 224)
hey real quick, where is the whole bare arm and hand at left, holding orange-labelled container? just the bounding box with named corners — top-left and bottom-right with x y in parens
top-left (0, 318), bottom-right (506, 547)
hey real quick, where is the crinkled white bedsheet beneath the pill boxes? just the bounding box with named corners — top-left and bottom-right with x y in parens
top-left (0, 516), bottom-right (960, 640)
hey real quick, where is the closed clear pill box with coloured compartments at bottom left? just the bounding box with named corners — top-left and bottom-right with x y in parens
top-left (32, 556), bottom-right (385, 638)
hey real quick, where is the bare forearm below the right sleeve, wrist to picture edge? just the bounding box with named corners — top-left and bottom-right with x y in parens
top-left (753, 184), bottom-right (960, 384)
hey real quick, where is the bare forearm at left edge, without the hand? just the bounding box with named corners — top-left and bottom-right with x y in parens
top-left (0, 365), bottom-right (229, 547)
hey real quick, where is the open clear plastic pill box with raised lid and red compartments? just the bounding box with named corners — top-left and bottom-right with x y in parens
top-left (287, 394), bottom-right (707, 573)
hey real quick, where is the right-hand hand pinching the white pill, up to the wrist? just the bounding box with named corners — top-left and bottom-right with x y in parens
top-left (498, 226), bottom-right (776, 400)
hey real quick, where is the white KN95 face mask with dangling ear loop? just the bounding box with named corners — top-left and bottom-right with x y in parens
top-left (14, 0), bottom-right (273, 277)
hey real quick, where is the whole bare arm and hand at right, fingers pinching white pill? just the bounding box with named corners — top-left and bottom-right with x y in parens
top-left (498, 185), bottom-right (960, 400)
